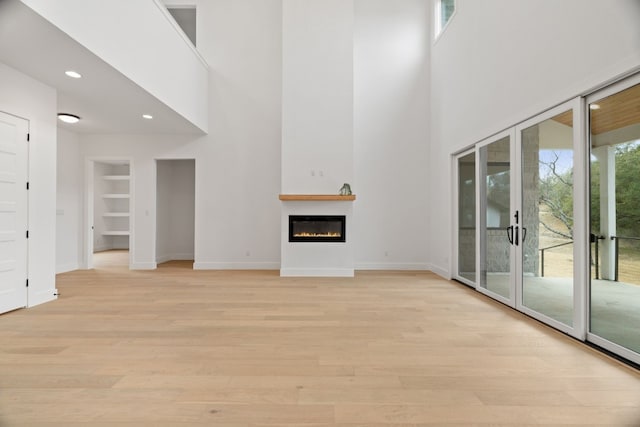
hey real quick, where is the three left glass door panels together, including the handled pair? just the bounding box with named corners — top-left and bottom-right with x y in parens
top-left (456, 99), bottom-right (586, 337)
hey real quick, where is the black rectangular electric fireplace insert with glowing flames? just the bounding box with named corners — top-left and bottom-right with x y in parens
top-left (289, 215), bottom-right (346, 242)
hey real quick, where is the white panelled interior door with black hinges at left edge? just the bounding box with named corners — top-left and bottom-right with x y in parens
top-left (0, 113), bottom-right (28, 313)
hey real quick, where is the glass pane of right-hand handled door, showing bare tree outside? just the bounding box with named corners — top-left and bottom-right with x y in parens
top-left (516, 110), bottom-right (574, 326)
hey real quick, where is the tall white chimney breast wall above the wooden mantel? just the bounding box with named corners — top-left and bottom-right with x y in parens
top-left (282, 0), bottom-right (354, 194)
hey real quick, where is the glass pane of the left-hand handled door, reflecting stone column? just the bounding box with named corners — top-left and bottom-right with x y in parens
top-left (478, 136), bottom-right (513, 303)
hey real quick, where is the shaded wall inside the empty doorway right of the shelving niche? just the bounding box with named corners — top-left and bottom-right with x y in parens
top-left (156, 160), bottom-right (195, 263)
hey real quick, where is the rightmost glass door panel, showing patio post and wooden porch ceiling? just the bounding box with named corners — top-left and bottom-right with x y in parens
top-left (589, 78), bottom-right (640, 362)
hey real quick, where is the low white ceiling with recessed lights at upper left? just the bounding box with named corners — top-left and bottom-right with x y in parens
top-left (0, 0), bottom-right (202, 134)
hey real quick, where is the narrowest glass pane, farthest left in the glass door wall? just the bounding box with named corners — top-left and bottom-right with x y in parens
top-left (457, 152), bottom-right (476, 286)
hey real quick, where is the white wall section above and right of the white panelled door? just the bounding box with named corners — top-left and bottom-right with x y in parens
top-left (0, 63), bottom-right (57, 306)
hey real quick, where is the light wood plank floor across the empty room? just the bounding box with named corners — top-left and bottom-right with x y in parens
top-left (0, 262), bottom-right (640, 427)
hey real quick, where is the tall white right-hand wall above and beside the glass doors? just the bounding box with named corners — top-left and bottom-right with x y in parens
top-left (429, 0), bottom-right (640, 276)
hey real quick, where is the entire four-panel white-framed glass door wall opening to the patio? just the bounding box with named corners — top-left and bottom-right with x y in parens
top-left (454, 75), bottom-right (640, 363)
